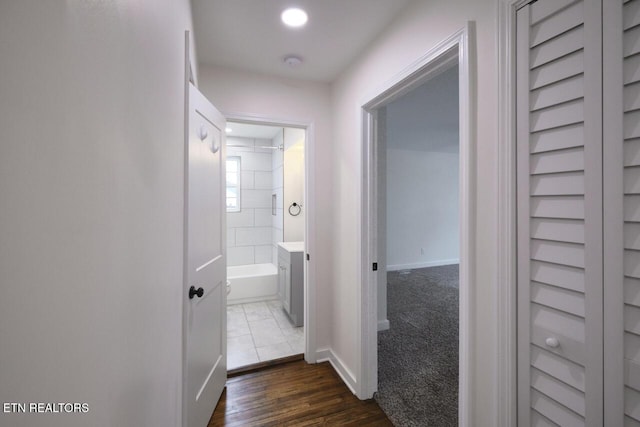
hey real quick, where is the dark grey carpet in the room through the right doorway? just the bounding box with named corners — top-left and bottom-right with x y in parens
top-left (375, 265), bottom-right (459, 427)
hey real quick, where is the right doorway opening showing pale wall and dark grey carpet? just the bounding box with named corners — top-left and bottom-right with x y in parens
top-left (375, 64), bottom-right (460, 425)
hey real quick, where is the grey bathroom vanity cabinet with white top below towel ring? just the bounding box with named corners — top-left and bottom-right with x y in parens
top-left (278, 242), bottom-right (304, 326)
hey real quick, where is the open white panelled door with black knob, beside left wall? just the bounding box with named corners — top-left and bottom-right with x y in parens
top-left (184, 84), bottom-right (227, 427)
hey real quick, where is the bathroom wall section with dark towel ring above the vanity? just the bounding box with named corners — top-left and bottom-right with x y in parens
top-left (283, 128), bottom-right (306, 242)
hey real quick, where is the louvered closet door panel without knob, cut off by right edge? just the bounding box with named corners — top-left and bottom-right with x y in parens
top-left (604, 0), bottom-right (640, 426)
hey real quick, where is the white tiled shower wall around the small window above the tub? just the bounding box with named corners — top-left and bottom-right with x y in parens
top-left (227, 137), bottom-right (280, 265)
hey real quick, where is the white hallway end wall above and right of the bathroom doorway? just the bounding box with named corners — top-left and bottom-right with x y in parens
top-left (199, 65), bottom-right (332, 349)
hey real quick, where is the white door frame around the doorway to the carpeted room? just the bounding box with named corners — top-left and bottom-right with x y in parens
top-left (357, 22), bottom-right (476, 426)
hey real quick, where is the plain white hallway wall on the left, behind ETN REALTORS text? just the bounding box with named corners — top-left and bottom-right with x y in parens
top-left (0, 0), bottom-right (191, 427)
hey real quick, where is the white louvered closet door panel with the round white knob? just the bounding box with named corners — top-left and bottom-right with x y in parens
top-left (516, 0), bottom-right (604, 427)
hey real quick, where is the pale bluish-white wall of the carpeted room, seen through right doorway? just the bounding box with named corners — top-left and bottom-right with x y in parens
top-left (386, 67), bottom-right (460, 270)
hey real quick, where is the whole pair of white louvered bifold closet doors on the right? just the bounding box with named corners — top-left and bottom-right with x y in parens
top-left (517, 0), bottom-right (640, 426)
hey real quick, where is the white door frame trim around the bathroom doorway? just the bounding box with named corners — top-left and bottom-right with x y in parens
top-left (222, 111), bottom-right (317, 363)
